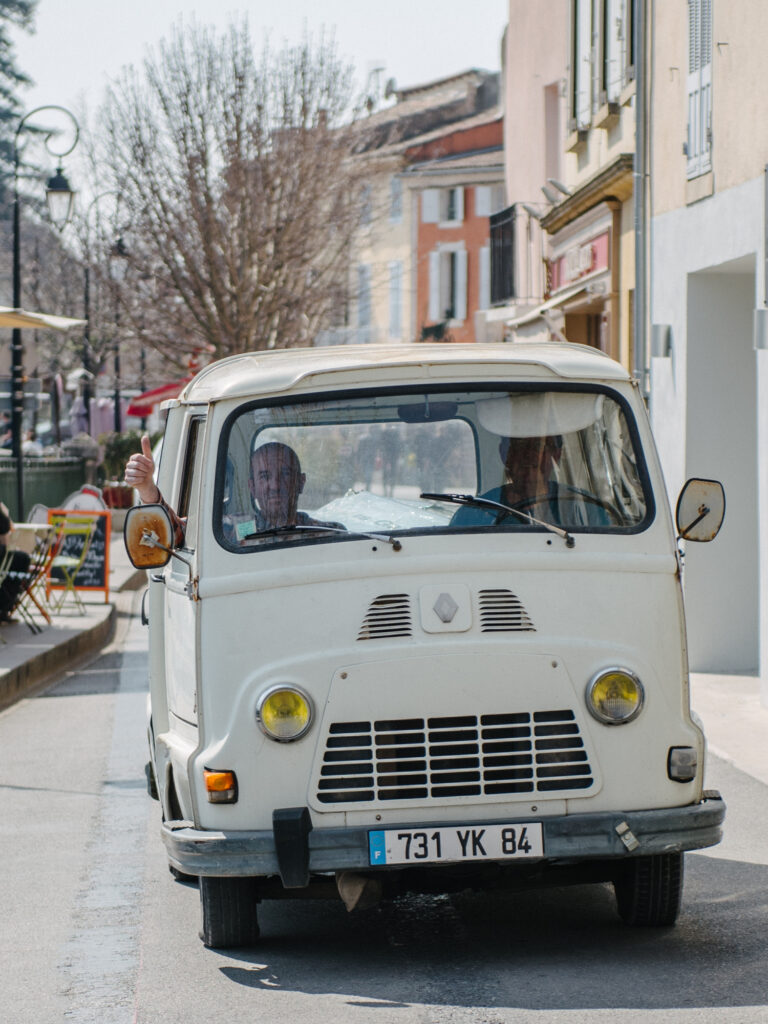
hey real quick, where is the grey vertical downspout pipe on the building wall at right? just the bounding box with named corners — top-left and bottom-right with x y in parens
top-left (633, 0), bottom-right (649, 401)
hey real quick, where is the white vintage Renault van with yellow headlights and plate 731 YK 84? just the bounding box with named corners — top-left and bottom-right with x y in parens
top-left (126, 343), bottom-right (725, 947)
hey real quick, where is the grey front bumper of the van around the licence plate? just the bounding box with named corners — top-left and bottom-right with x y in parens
top-left (163, 792), bottom-right (725, 888)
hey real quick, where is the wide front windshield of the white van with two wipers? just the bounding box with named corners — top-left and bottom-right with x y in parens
top-left (214, 385), bottom-right (652, 551)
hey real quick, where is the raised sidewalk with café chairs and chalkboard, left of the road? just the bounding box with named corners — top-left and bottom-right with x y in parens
top-left (0, 532), bottom-right (146, 710)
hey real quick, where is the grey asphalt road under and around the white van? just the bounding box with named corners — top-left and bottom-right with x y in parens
top-left (0, 594), bottom-right (768, 1024)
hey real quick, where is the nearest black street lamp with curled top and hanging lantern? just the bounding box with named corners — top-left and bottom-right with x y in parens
top-left (10, 105), bottom-right (80, 519)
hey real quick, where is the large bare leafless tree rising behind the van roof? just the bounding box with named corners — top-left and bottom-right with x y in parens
top-left (91, 23), bottom-right (374, 366)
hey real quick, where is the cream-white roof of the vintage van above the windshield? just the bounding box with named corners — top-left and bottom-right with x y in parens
top-left (177, 341), bottom-right (630, 404)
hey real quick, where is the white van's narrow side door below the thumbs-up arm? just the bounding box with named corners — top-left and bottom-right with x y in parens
top-left (164, 412), bottom-right (206, 728)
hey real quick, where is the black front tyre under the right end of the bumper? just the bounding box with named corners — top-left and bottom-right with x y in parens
top-left (613, 853), bottom-right (683, 928)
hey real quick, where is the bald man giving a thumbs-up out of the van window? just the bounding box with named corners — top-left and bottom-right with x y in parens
top-left (125, 434), bottom-right (345, 547)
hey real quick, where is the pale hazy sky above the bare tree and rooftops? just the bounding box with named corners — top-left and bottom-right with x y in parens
top-left (14, 0), bottom-right (508, 112)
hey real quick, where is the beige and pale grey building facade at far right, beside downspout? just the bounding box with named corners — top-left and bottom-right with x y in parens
top-left (648, 0), bottom-right (768, 703)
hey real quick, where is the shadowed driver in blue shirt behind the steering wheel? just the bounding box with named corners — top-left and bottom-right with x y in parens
top-left (451, 435), bottom-right (611, 526)
